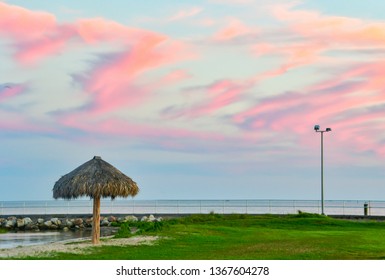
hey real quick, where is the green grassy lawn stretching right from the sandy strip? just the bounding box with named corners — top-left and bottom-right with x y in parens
top-left (13, 213), bottom-right (385, 260)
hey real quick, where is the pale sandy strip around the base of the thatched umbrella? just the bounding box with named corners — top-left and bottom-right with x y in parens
top-left (0, 236), bottom-right (158, 258)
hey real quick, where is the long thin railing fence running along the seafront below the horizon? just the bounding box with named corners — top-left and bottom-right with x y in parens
top-left (0, 200), bottom-right (385, 216)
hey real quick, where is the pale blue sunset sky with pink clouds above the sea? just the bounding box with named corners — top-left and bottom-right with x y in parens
top-left (0, 0), bottom-right (385, 201)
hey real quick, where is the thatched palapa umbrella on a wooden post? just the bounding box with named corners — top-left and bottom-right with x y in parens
top-left (53, 156), bottom-right (139, 244)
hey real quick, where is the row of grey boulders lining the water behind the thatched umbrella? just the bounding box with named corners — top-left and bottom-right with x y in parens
top-left (0, 215), bottom-right (162, 231)
